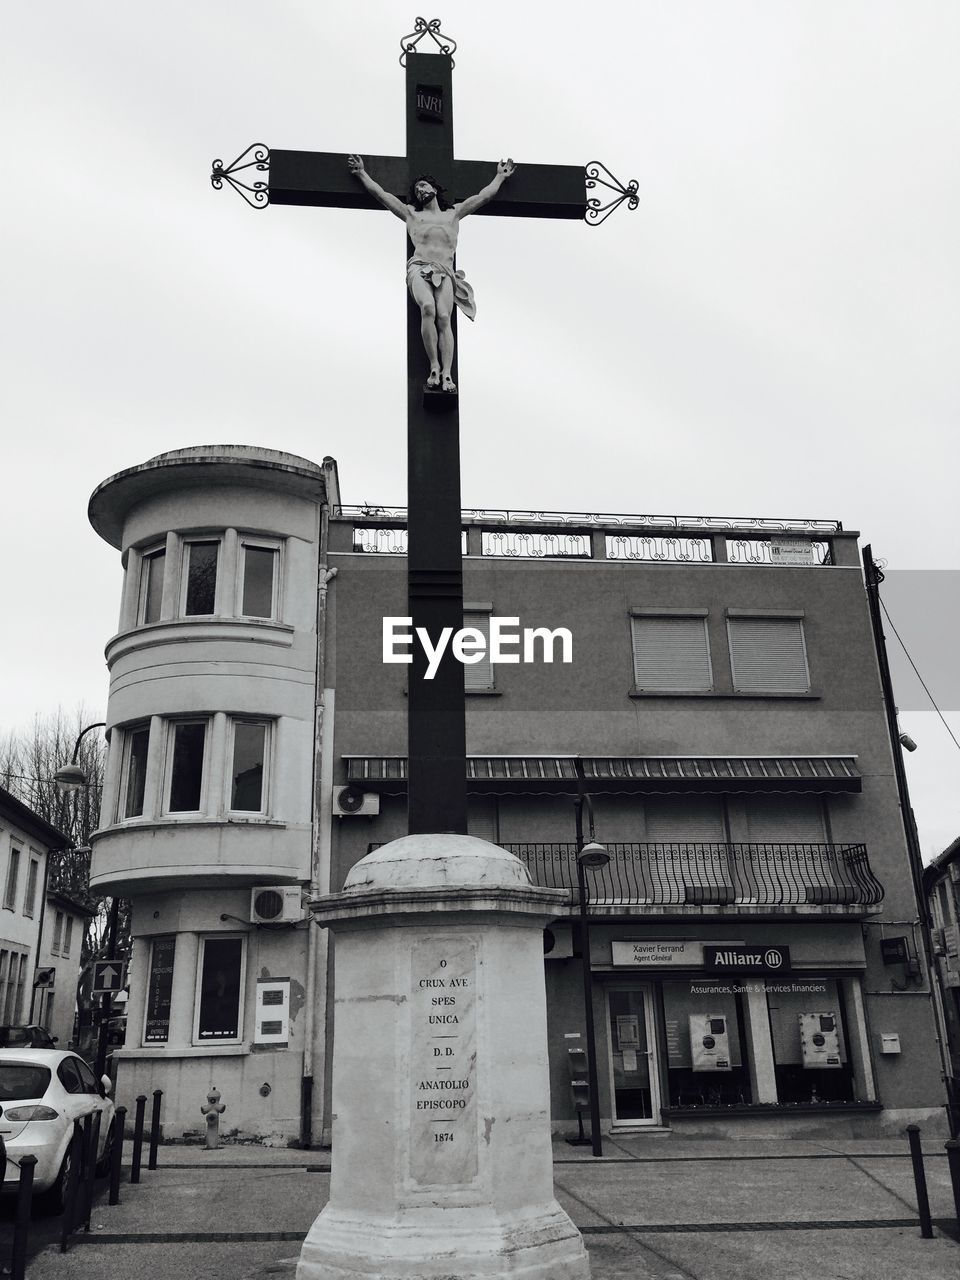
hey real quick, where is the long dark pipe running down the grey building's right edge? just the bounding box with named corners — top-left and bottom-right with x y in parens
top-left (863, 545), bottom-right (954, 1134)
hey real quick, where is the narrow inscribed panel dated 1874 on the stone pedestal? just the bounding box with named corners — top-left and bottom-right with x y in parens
top-left (410, 934), bottom-right (477, 1187)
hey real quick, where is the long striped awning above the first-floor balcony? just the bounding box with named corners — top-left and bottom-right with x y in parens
top-left (343, 755), bottom-right (861, 795)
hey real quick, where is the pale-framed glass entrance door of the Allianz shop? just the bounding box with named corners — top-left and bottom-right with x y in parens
top-left (607, 983), bottom-right (660, 1129)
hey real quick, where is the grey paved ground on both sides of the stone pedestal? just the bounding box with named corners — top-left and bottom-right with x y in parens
top-left (13, 1135), bottom-right (960, 1280)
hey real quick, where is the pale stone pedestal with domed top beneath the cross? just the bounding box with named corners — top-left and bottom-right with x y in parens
top-left (297, 835), bottom-right (590, 1280)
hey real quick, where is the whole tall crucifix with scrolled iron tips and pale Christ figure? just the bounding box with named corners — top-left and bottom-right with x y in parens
top-left (211, 18), bottom-right (639, 835)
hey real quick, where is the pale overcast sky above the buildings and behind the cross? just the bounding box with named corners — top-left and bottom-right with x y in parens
top-left (0, 0), bottom-right (960, 856)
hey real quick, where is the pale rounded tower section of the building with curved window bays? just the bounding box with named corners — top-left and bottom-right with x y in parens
top-left (90, 445), bottom-right (337, 1140)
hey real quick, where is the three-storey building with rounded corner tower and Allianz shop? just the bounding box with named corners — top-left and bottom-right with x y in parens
top-left (82, 445), bottom-right (945, 1142)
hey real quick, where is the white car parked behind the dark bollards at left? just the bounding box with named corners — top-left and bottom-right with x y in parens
top-left (0, 1047), bottom-right (114, 1212)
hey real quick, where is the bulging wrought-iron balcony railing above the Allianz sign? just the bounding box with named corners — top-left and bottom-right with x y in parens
top-left (503, 842), bottom-right (883, 908)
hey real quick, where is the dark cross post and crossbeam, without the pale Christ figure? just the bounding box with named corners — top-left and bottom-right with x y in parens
top-left (212, 35), bottom-right (593, 835)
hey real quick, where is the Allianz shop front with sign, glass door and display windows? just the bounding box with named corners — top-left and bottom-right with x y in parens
top-left (552, 923), bottom-right (881, 1133)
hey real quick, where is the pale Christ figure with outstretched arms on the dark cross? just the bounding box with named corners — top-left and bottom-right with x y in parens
top-left (347, 156), bottom-right (516, 394)
